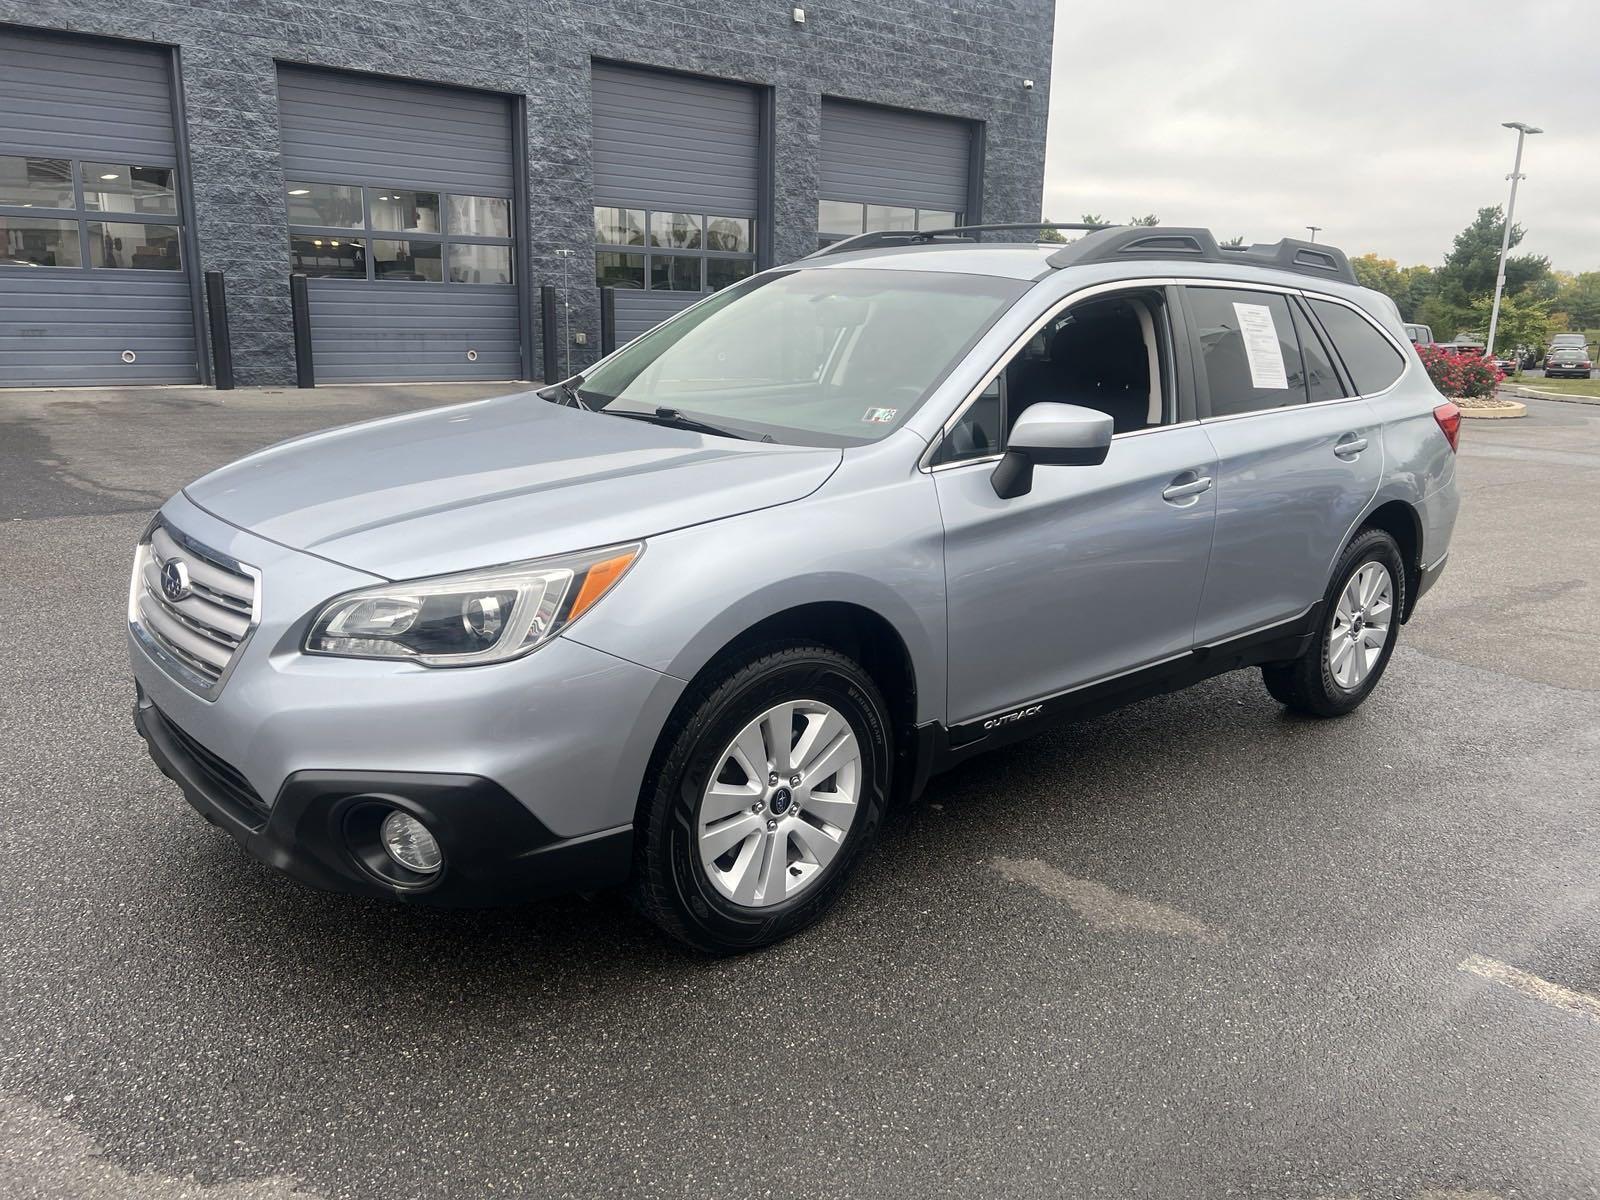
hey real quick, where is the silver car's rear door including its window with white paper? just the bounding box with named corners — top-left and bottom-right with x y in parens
top-left (1184, 283), bottom-right (1384, 646)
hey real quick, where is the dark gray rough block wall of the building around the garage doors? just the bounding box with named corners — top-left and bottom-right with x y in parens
top-left (0, 0), bottom-right (1054, 384)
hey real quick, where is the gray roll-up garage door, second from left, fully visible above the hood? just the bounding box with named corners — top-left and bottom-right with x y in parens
top-left (278, 67), bottom-right (523, 382)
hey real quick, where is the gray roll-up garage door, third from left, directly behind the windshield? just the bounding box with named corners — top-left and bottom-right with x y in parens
top-left (592, 62), bottom-right (760, 342)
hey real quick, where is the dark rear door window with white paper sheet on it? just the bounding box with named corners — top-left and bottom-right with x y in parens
top-left (1186, 288), bottom-right (1306, 418)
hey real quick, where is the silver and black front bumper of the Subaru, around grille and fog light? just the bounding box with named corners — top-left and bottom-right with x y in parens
top-left (130, 494), bottom-right (685, 904)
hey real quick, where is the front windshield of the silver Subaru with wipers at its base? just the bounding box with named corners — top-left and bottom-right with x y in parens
top-left (579, 267), bottom-right (1027, 446)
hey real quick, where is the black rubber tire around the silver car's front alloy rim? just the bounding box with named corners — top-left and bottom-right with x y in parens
top-left (632, 645), bottom-right (894, 955)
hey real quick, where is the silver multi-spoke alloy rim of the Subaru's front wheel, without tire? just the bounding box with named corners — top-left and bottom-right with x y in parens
top-left (696, 699), bottom-right (861, 909)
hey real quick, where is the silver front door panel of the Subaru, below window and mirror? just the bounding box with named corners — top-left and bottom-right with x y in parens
top-left (934, 426), bottom-right (1216, 725)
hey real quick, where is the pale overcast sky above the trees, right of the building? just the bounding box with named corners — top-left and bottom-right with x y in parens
top-left (1045, 0), bottom-right (1600, 270)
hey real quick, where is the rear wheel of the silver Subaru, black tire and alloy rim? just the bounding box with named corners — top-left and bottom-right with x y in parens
top-left (1261, 530), bottom-right (1405, 717)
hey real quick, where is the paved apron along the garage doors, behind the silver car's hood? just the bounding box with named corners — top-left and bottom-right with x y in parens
top-left (0, 381), bottom-right (541, 520)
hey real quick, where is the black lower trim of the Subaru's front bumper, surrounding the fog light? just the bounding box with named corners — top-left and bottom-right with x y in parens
top-left (133, 696), bottom-right (634, 907)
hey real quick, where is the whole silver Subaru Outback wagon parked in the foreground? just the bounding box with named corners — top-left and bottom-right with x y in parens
top-left (128, 229), bottom-right (1459, 952)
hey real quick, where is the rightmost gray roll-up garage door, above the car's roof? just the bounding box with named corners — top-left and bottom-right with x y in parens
top-left (818, 99), bottom-right (973, 240)
